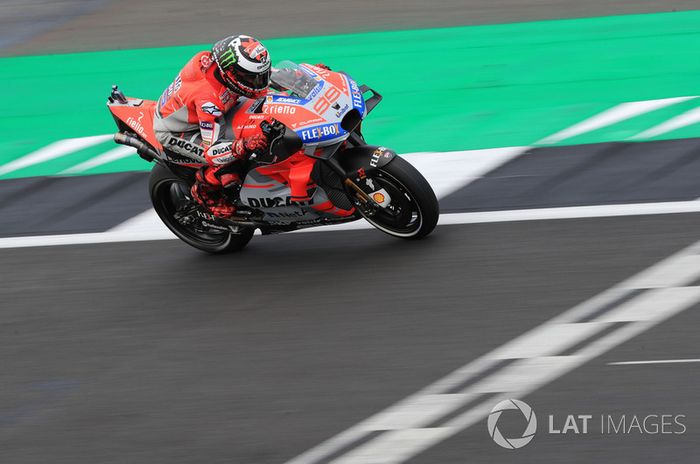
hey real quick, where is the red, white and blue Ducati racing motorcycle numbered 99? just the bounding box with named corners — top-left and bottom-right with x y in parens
top-left (107, 62), bottom-right (439, 253)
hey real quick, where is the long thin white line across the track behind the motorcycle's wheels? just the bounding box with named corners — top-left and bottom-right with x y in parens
top-left (0, 200), bottom-right (700, 249)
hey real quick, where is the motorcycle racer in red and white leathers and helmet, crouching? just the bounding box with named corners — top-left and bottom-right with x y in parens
top-left (153, 35), bottom-right (271, 218)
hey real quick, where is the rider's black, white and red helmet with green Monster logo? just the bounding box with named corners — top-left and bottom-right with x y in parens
top-left (211, 35), bottom-right (270, 98)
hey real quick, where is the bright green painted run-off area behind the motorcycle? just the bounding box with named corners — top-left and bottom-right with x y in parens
top-left (0, 11), bottom-right (700, 177)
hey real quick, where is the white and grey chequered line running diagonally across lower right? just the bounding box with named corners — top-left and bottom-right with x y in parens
top-left (287, 242), bottom-right (700, 464)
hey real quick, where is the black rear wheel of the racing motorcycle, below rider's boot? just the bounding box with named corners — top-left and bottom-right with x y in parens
top-left (149, 164), bottom-right (255, 253)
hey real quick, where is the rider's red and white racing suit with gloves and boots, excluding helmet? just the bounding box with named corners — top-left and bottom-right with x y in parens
top-left (153, 51), bottom-right (267, 217)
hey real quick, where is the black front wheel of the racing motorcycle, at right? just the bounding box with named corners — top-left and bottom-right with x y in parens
top-left (358, 156), bottom-right (440, 240)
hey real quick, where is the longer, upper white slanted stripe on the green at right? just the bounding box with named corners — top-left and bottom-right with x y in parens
top-left (537, 97), bottom-right (698, 145)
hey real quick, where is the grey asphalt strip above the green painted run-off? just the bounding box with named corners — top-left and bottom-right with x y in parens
top-left (5, 0), bottom-right (700, 55)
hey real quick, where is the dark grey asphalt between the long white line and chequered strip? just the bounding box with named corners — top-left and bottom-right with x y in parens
top-left (0, 214), bottom-right (700, 464)
